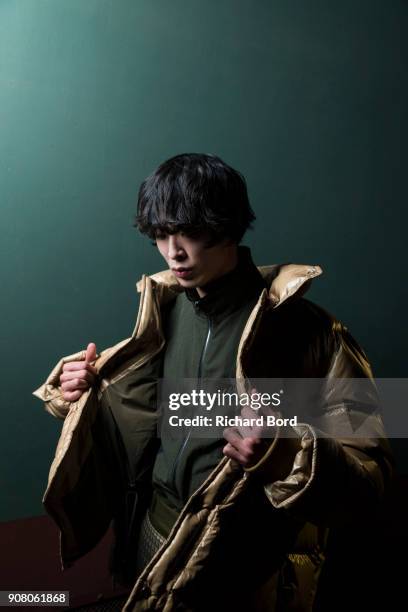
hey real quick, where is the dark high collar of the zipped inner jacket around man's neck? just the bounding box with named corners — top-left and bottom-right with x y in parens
top-left (185, 246), bottom-right (266, 319)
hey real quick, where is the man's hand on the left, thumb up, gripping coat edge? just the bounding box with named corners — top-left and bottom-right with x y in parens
top-left (60, 342), bottom-right (97, 402)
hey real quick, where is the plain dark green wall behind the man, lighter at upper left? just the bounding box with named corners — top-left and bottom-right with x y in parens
top-left (0, 0), bottom-right (408, 520)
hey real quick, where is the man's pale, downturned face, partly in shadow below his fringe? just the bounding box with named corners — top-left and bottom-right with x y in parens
top-left (156, 231), bottom-right (237, 296)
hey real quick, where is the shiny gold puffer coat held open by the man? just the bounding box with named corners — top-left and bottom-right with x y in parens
top-left (34, 264), bottom-right (392, 612)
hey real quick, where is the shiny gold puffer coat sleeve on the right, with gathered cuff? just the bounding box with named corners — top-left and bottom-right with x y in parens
top-left (247, 321), bottom-right (393, 526)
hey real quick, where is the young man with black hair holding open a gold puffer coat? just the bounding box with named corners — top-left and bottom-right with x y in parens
top-left (36, 154), bottom-right (391, 612)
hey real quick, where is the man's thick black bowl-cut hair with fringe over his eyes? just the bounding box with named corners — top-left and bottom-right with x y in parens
top-left (134, 153), bottom-right (255, 246)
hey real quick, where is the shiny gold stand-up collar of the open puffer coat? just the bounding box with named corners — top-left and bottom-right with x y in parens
top-left (136, 250), bottom-right (323, 307)
